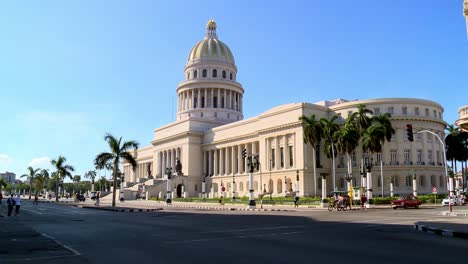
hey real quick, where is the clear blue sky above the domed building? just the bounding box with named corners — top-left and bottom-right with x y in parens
top-left (0, 0), bottom-right (468, 180)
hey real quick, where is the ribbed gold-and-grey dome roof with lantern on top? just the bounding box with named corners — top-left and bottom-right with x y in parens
top-left (187, 20), bottom-right (235, 65)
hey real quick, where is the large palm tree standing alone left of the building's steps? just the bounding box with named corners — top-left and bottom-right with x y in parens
top-left (94, 133), bottom-right (138, 207)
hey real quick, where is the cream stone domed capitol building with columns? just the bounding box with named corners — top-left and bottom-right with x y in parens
top-left (123, 21), bottom-right (446, 197)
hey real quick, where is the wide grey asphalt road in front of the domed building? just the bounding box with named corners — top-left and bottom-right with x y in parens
top-left (0, 201), bottom-right (468, 264)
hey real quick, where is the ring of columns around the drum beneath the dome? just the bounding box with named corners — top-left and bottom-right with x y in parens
top-left (177, 88), bottom-right (243, 112)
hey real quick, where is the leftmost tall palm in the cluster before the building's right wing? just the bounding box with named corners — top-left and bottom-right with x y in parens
top-left (299, 114), bottom-right (322, 196)
